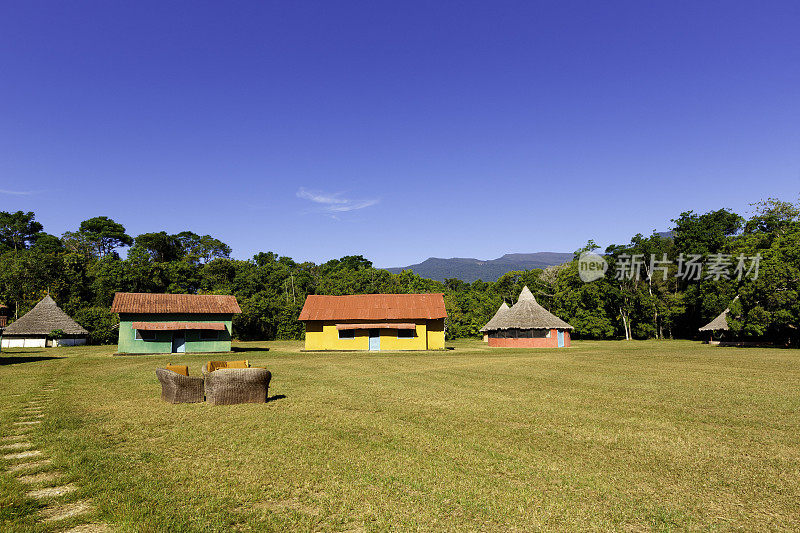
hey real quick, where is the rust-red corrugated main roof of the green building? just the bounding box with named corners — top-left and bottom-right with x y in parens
top-left (111, 292), bottom-right (242, 315)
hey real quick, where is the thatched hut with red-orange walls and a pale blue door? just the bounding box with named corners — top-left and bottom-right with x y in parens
top-left (487, 287), bottom-right (573, 348)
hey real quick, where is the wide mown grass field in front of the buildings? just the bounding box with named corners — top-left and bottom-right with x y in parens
top-left (0, 341), bottom-right (800, 531)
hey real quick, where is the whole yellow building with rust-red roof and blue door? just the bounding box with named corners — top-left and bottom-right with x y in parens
top-left (300, 293), bottom-right (447, 351)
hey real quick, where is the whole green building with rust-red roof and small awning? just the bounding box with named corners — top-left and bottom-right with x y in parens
top-left (111, 292), bottom-right (242, 354)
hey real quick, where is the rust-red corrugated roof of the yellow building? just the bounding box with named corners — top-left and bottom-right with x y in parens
top-left (300, 293), bottom-right (447, 321)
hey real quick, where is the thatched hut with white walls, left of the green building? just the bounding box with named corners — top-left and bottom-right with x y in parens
top-left (2, 295), bottom-right (89, 348)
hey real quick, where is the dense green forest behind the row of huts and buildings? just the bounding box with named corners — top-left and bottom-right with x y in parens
top-left (0, 195), bottom-right (800, 346)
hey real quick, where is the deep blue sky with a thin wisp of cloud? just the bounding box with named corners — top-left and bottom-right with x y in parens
top-left (0, 1), bottom-right (800, 266)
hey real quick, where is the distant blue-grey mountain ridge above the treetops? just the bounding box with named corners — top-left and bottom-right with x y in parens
top-left (386, 252), bottom-right (573, 282)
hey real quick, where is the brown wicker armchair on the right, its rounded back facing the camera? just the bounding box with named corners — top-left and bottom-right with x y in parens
top-left (204, 368), bottom-right (272, 405)
